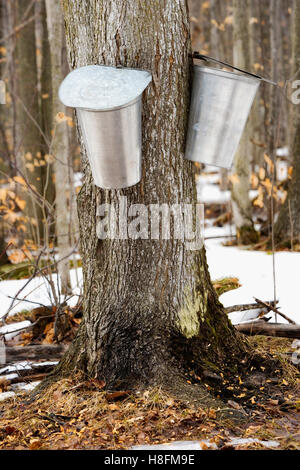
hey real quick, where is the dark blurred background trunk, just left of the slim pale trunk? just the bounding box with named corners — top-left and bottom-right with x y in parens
top-left (15, 0), bottom-right (44, 244)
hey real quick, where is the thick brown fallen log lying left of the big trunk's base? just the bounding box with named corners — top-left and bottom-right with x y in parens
top-left (5, 344), bottom-right (67, 363)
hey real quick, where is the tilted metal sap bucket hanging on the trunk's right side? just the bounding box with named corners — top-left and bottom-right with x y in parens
top-left (185, 56), bottom-right (262, 169)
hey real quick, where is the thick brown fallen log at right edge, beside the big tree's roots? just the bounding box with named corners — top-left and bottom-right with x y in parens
top-left (235, 320), bottom-right (300, 339)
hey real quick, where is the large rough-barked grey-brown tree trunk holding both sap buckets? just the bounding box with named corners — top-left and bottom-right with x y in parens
top-left (51, 0), bottom-right (245, 396)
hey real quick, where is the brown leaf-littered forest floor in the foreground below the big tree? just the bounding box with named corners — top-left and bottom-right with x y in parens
top-left (0, 337), bottom-right (300, 450)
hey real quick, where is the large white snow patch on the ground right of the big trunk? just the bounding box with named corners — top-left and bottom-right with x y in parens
top-left (205, 226), bottom-right (300, 323)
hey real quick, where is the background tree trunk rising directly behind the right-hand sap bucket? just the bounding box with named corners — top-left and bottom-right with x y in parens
top-left (231, 0), bottom-right (257, 244)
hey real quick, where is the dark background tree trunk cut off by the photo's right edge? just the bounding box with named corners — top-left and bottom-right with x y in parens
top-left (275, 0), bottom-right (300, 247)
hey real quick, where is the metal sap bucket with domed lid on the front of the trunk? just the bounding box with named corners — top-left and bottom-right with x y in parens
top-left (59, 65), bottom-right (151, 189)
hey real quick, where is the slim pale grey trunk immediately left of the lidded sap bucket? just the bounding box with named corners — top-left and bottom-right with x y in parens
top-left (46, 0), bottom-right (72, 294)
